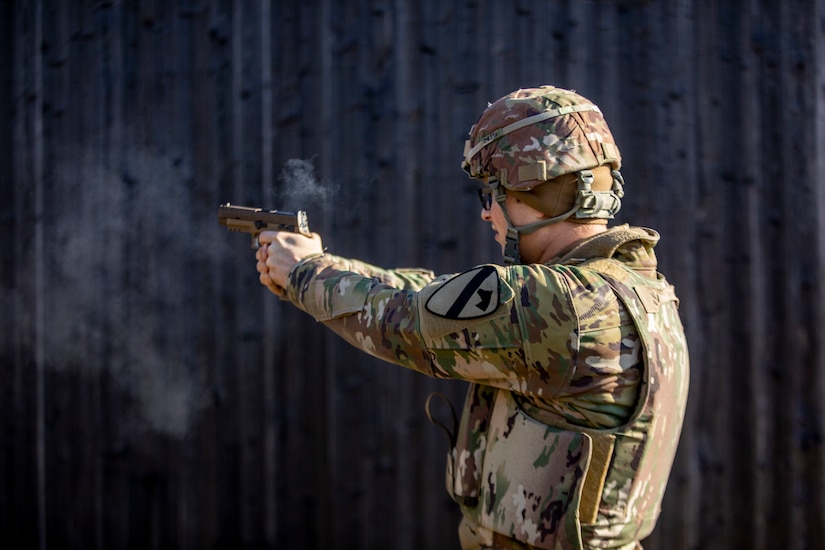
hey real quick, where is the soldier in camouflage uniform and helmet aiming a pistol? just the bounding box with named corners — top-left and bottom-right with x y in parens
top-left (257, 86), bottom-right (688, 550)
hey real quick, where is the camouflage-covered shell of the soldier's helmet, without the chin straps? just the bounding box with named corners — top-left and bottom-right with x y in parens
top-left (462, 86), bottom-right (621, 191)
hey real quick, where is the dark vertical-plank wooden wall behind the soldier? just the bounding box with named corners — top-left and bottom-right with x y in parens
top-left (0, 0), bottom-right (825, 550)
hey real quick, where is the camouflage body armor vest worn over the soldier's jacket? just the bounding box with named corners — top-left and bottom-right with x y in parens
top-left (447, 259), bottom-right (688, 550)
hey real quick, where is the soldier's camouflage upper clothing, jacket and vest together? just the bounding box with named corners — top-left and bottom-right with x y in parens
top-left (287, 225), bottom-right (688, 549)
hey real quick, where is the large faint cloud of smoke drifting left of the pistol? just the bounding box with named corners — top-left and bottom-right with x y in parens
top-left (48, 140), bottom-right (209, 437)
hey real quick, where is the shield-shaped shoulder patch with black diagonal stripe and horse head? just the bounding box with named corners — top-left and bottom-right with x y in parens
top-left (425, 265), bottom-right (500, 319)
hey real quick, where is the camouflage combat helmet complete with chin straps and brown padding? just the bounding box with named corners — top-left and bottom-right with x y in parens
top-left (461, 86), bottom-right (624, 264)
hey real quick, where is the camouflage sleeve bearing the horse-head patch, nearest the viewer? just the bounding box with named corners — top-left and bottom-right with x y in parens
top-left (287, 255), bottom-right (575, 397)
